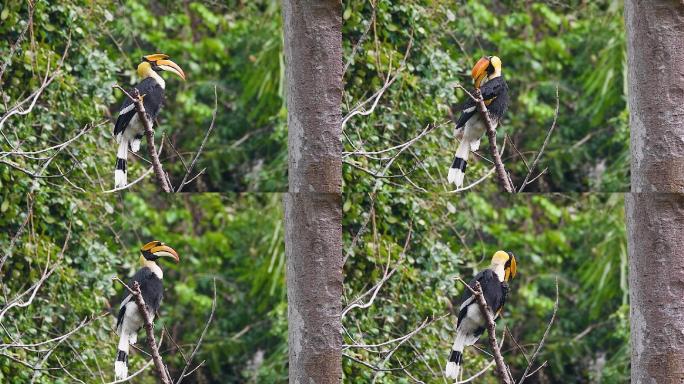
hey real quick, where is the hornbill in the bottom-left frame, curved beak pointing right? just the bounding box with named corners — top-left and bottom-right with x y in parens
top-left (114, 240), bottom-right (178, 380)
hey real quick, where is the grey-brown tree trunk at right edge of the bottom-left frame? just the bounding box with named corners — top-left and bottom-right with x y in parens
top-left (283, 193), bottom-right (344, 384)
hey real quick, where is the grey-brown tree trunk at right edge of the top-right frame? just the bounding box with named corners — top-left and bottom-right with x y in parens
top-left (625, 0), bottom-right (684, 192)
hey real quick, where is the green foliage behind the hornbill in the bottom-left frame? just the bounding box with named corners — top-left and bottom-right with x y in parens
top-left (0, 188), bottom-right (287, 383)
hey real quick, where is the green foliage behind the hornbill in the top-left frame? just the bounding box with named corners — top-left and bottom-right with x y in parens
top-left (0, 0), bottom-right (287, 192)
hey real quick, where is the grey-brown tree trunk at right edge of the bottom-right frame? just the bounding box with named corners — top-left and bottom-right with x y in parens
top-left (625, 193), bottom-right (684, 383)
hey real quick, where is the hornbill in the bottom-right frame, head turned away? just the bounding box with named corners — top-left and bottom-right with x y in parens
top-left (445, 251), bottom-right (517, 379)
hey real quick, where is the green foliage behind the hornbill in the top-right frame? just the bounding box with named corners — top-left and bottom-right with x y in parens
top-left (343, 0), bottom-right (629, 192)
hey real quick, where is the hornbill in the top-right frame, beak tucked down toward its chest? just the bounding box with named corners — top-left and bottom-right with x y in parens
top-left (447, 56), bottom-right (508, 188)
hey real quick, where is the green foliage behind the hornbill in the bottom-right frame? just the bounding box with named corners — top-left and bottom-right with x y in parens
top-left (343, 194), bottom-right (630, 383)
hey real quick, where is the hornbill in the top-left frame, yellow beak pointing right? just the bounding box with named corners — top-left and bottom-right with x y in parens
top-left (114, 53), bottom-right (185, 188)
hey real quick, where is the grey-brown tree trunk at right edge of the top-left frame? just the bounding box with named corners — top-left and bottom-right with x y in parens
top-left (283, 0), bottom-right (343, 193)
